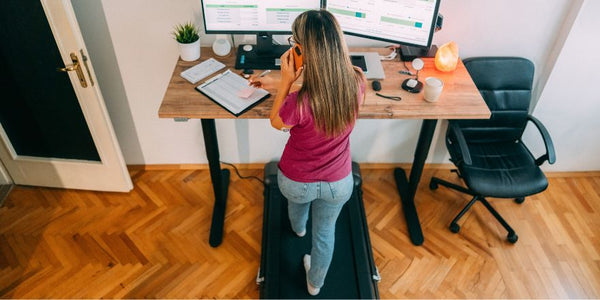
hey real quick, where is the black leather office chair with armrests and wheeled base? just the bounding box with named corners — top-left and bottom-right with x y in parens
top-left (429, 57), bottom-right (556, 243)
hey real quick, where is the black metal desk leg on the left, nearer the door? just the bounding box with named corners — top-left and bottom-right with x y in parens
top-left (201, 119), bottom-right (229, 247)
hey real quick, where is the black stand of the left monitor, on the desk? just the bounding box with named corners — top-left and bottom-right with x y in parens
top-left (235, 32), bottom-right (290, 70)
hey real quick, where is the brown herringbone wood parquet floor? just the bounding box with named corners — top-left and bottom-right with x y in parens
top-left (0, 169), bottom-right (600, 298)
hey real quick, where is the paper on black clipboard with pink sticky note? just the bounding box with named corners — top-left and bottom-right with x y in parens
top-left (196, 70), bottom-right (270, 117)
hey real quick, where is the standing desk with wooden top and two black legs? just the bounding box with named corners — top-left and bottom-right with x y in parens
top-left (158, 48), bottom-right (491, 247)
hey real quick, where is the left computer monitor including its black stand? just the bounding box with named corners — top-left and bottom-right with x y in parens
top-left (202, 0), bottom-right (321, 69)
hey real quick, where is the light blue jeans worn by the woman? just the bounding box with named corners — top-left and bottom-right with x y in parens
top-left (277, 170), bottom-right (354, 288)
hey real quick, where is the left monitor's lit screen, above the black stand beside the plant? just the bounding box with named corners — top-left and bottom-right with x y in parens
top-left (202, 0), bottom-right (321, 34)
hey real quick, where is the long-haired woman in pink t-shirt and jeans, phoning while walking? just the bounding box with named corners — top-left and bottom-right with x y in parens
top-left (251, 10), bottom-right (366, 296)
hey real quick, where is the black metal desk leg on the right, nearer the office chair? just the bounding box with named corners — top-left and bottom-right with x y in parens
top-left (394, 120), bottom-right (437, 245)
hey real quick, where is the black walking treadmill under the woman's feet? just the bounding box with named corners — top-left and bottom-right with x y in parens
top-left (256, 162), bottom-right (380, 299)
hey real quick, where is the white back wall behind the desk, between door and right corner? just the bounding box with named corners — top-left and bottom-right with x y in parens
top-left (72, 0), bottom-right (600, 169)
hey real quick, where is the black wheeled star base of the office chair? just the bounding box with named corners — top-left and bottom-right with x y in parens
top-left (429, 177), bottom-right (525, 244)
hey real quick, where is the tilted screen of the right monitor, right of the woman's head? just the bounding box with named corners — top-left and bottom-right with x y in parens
top-left (325, 0), bottom-right (440, 48)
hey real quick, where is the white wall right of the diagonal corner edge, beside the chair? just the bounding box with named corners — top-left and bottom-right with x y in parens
top-left (524, 0), bottom-right (600, 171)
